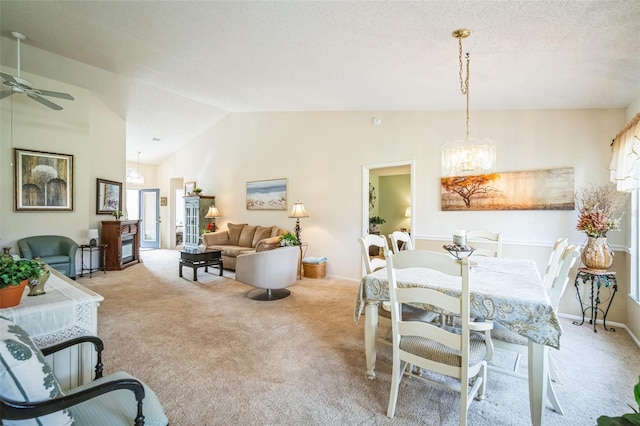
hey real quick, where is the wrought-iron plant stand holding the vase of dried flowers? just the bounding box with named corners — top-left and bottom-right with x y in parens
top-left (573, 268), bottom-right (618, 333)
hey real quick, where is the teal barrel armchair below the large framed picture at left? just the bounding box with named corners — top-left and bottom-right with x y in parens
top-left (18, 235), bottom-right (78, 279)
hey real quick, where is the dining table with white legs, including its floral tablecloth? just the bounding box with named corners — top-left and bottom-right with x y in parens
top-left (353, 256), bottom-right (562, 426)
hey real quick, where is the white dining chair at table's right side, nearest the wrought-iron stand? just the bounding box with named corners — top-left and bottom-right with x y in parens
top-left (489, 245), bottom-right (580, 414)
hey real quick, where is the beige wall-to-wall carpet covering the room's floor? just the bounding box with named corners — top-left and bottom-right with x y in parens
top-left (78, 250), bottom-right (640, 426)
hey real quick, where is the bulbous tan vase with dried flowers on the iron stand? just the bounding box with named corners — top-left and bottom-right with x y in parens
top-left (576, 185), bottom-right (627, 271)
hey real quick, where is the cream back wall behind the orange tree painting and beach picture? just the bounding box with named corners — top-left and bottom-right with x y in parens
top-left (158, 109), bottom-right (628, 280)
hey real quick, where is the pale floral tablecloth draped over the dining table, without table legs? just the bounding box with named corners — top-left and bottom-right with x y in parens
top-left (354, 256), bottom-right (562, 349)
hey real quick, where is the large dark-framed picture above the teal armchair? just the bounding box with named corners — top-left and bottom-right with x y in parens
top-left (14, 148), bottom-right (73, 211)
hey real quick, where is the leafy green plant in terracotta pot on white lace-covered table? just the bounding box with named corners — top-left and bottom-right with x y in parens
top-left (0, 256), bottom-right (44, 308)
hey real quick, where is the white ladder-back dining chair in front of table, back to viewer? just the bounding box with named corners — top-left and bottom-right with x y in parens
top-left (386, 250), bottom-right (493, 425)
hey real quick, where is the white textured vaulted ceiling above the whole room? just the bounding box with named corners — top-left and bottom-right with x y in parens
top-left (0, 0), bottom-right (640, 163)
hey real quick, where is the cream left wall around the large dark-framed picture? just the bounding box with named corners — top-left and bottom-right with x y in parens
top-left (0, 70), bottom-right (125, 253)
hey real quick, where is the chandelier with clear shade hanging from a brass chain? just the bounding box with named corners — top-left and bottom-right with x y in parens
top-left (442, 29), bottom-right (496, 176)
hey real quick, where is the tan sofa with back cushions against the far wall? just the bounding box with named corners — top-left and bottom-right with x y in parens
top-left (202, 223), bottom-right (290, 271)
